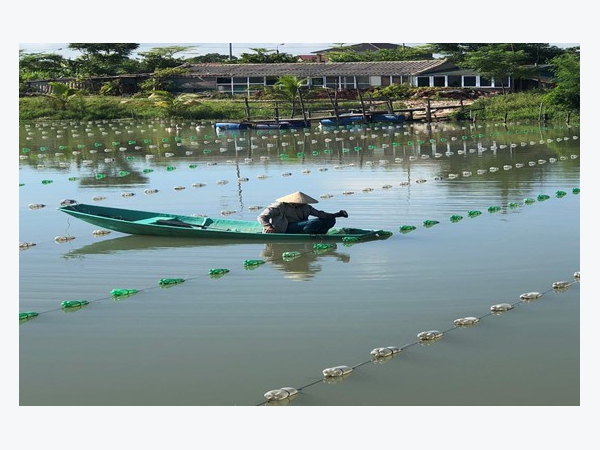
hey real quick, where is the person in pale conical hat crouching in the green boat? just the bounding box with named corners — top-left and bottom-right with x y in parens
top-left (258, 191), bottom-right (348, 234)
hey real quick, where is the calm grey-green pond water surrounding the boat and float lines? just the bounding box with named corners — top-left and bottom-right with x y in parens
top-left (18, 120), bottom-right (581, 416)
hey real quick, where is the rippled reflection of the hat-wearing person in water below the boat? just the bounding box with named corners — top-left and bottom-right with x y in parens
top-left (261, 242), bottom-right (350, 281)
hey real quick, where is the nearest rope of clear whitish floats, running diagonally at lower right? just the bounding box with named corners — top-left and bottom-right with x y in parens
top-left (255, 272), bottom-right (580, 406)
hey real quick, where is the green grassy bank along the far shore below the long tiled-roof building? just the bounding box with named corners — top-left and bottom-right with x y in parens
top-left (19, 92), bottom-right (579, 123)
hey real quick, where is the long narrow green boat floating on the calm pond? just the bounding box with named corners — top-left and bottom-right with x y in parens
top-left (58, 203), bottom-right (392, 242)
